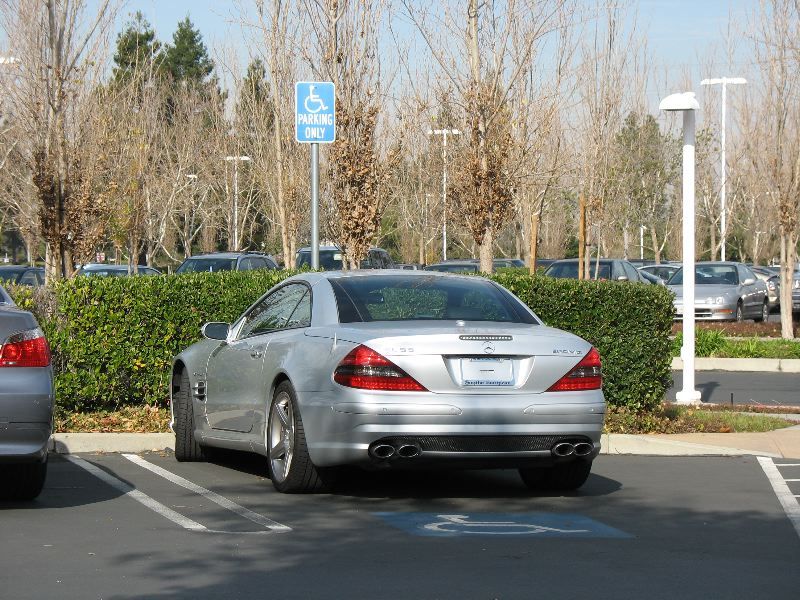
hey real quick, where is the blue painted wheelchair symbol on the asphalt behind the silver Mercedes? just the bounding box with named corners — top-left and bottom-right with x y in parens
top-left (374, 513), bottom-right (631, 538)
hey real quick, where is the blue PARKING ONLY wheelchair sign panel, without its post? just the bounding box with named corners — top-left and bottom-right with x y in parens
top-left (294, 81), bottom-right (336, 144)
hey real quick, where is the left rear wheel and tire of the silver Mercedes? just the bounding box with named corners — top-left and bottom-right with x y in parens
top-left (264, 381), bottom-right (324, 494)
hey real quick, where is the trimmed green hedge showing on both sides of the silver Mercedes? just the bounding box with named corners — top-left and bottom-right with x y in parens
top-left (12, 271), bottom-right (672, 411)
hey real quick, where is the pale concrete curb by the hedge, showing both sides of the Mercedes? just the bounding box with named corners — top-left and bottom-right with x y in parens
top-left (50, 433), bottom-right (781, 458)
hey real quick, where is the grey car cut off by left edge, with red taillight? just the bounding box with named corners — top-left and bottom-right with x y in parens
top-left (0, 287), bottom-right (54, 500)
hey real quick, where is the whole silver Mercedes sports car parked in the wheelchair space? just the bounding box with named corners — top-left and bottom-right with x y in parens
top-left (171, 270), bottom-right (606, 492)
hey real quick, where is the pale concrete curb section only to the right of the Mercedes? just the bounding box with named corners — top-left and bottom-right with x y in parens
top-left (600, 433), bottom-right (782, 458)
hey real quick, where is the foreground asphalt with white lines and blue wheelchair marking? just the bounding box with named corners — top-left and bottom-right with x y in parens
top-left (0, 452), bottom-right (800, 600)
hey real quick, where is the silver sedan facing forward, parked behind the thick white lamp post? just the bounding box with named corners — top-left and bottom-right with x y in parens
top-left (667, 262), bottom-right (769, 321)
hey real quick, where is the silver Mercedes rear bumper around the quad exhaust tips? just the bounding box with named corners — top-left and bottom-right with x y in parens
top-left (300, 390), bottom-right (605, 468)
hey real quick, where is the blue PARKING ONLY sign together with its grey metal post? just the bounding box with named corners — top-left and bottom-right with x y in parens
top-left (294, 81), bottom-right (336, 269)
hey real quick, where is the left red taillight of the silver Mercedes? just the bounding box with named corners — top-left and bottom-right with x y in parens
top-left (333, 346), bottom-right (427, 392)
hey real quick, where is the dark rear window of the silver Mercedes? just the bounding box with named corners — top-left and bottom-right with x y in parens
top-left (330, 275), bottom-right (538, 325)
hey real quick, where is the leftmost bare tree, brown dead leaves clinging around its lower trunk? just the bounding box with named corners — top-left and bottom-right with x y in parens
top-left (0, 0), bottom-right (117, 279)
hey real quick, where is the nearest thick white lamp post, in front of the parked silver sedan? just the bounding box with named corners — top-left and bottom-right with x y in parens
top-left (658, 92), bottom-right (700, 404)
